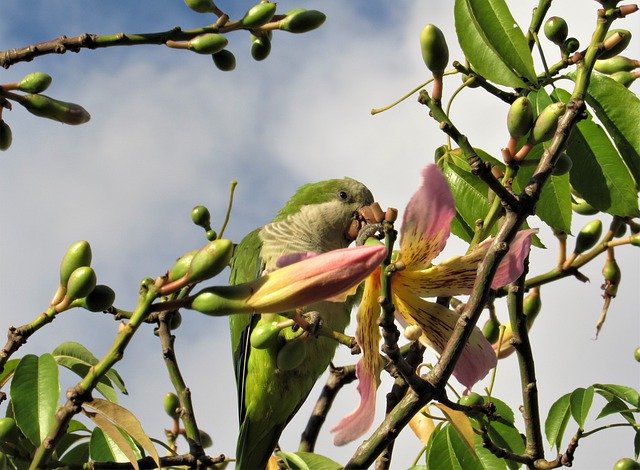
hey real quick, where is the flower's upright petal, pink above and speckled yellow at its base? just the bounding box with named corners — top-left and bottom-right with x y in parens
top-left (400, 165), bottom-right (456, 269)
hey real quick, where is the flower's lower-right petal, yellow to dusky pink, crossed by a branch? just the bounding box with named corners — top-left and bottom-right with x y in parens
top-left (393, 289), bottom-right (497, 389)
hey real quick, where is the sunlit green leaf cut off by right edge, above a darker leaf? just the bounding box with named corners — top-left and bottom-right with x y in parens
top-left (580, 73), bottom-right (640, 185)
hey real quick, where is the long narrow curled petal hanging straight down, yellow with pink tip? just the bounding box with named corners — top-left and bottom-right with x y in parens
top-left (331, 269), bottom-right (382, 446)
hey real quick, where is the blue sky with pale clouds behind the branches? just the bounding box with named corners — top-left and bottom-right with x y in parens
top-left (0, 0), bottom-right (640, 468)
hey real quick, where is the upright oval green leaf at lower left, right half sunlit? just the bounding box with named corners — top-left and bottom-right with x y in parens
top-left (10, 354), bottom-right (60, 446)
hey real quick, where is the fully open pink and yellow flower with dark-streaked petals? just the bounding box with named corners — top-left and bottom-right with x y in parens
top-left (331, 165), bottom-right (535, 445)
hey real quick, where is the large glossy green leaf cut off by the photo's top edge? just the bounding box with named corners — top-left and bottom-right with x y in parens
top-left (454, 0), bottom-right (537, 88)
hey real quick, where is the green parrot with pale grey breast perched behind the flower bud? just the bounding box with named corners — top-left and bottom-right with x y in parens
top-left (229, 178), bottom-right (373, 470)
